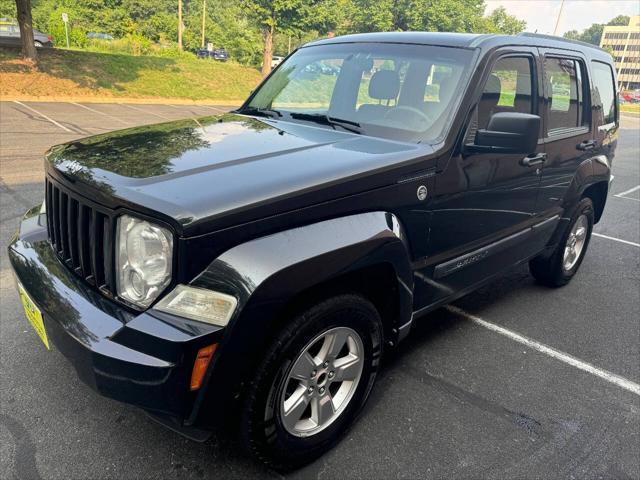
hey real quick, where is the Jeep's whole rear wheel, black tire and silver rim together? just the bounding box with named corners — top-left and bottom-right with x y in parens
top-left (529, 198), bottom-right (594, 287)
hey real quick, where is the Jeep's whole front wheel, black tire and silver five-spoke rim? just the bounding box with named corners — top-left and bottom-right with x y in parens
top-left (242, 295), bottom-right (383, 470)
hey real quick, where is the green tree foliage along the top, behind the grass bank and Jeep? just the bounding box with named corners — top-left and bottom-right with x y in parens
top-left (10, 0), bottom-right (528, 65)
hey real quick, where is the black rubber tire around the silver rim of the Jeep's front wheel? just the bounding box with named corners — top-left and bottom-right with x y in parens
top-left (241, 295), bottom-right (383, 471)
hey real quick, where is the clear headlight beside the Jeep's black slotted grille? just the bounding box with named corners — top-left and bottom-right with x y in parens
top-left (116, 215), bottom-right (173, 307)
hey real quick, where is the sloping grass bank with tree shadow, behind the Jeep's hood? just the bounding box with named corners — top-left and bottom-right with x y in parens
top-left (0, 48), bottom-right (261, 102)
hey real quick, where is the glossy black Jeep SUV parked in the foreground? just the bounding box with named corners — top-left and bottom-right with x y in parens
top-left (9, 33), bottom-right (619, 468)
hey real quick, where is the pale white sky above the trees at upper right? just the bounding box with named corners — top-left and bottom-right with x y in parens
top-left (486, 0), bottom-right (640, 35)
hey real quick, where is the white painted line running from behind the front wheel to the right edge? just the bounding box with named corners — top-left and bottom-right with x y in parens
top-left (445, 305), bottom-right (640, 395)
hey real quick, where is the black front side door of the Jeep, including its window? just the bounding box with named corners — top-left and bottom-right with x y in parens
top-left (416, 48), bottom-right (544, 306)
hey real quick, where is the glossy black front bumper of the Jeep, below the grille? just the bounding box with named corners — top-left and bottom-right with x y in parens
top-left (9, 208), bottom-right (222, 424)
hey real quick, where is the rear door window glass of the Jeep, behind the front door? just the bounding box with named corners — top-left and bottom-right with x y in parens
top-left (544, 58), bottom-right (584, 131)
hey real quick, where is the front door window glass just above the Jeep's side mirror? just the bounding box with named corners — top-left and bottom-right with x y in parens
top-left (478, 57), bottom-right (534, 128)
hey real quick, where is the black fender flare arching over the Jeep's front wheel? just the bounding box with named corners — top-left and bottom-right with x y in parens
top-left (186, 211), bottom-right (413, 424)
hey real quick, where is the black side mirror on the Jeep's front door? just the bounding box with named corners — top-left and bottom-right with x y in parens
top-left (467, 112), bottom-right (540, 154)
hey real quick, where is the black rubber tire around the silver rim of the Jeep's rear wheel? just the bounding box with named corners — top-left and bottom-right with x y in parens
top-left (529, 198), bottom-right (594, 288)
